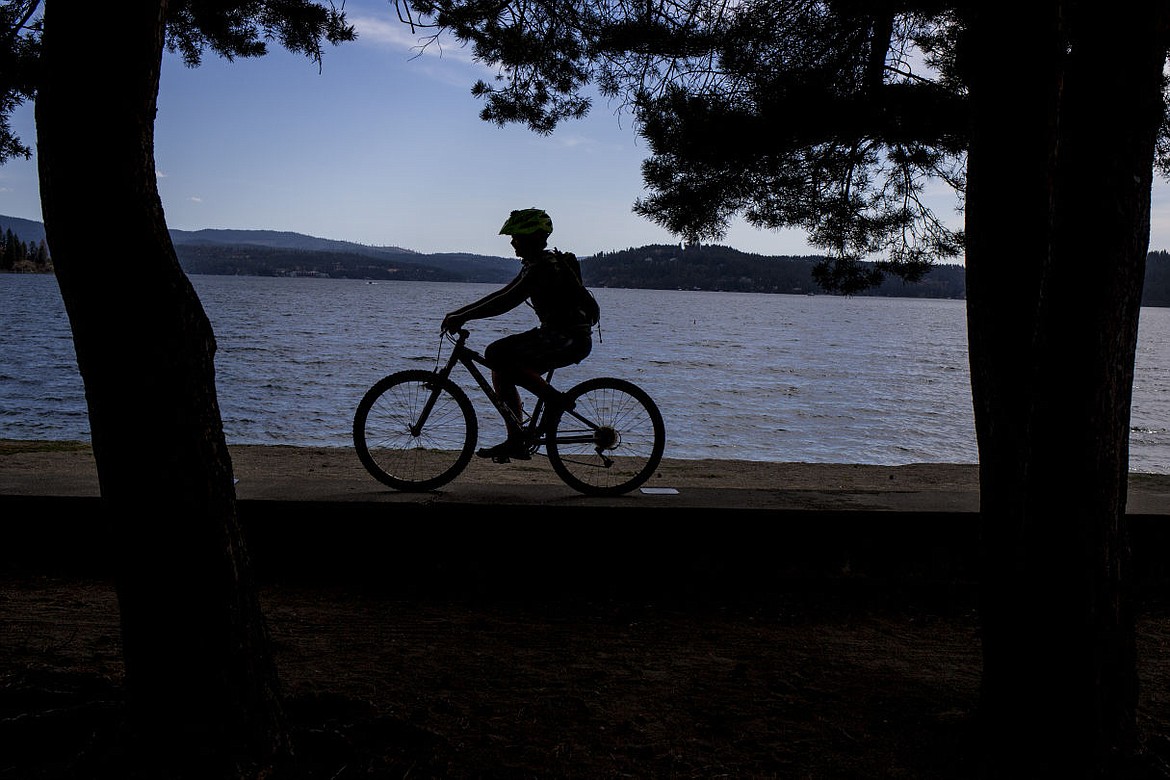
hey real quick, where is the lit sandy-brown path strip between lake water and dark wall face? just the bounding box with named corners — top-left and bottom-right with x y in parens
top-left (0, 440), bottom-right (1170, 516)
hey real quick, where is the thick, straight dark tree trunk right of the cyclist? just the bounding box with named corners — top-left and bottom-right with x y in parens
top-left (966, 2), bottom-right (1166, 778)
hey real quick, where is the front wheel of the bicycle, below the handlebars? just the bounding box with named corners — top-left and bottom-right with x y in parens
top-left (353, 370), bottom-right (479, 491)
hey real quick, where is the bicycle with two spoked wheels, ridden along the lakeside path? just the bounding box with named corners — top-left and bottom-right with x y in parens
top-left (353, 330), bottom-right (666, 496)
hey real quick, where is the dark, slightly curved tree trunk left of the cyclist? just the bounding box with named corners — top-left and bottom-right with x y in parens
top-left (36, 0), bottom-right (289, 776)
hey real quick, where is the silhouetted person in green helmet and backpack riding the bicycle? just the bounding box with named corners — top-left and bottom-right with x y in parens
top-left (442, 208), bottom-right (593, 463)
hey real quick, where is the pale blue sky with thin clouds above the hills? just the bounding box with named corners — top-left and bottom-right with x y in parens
top-left (0, 0), bottom-right (1170, 257)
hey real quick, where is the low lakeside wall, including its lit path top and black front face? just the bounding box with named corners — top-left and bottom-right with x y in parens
top-left (0, 447), bottom-right (1170, 598)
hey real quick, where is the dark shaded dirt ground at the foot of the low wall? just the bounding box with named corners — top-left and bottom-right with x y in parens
top-left (0, 578), bottom-right (1170, 780)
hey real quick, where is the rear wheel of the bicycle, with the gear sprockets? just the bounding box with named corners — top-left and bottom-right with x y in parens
top-left (545, 377), bottom-right (666, 496)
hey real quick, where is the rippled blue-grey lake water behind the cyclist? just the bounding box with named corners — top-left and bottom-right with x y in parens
top-left (0, 275), bottom-right (1170, 474)
